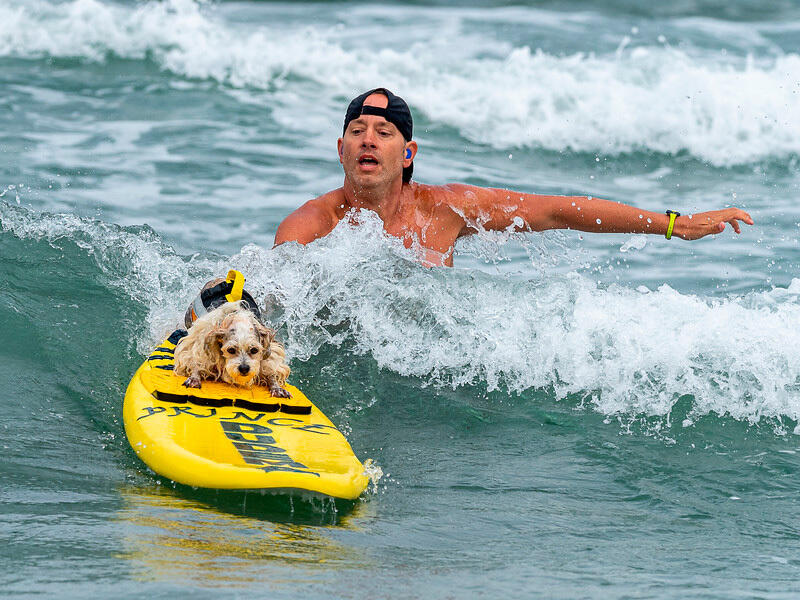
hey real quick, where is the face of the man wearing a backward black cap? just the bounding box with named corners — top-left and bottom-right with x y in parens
top-left (338, 94), bottom-right (415, 189)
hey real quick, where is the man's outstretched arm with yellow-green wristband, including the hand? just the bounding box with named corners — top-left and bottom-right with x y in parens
top-left (448, 185), bottom-right (753, 240)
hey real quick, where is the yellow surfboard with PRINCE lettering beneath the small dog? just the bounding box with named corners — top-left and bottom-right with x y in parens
top-left (122, 330), bottom-right (368, 500)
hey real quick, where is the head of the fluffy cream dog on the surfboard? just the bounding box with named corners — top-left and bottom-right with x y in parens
top-left (214, 308), bottom-right (275, 387)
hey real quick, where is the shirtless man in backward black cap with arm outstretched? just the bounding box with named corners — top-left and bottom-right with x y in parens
top-left (275, 88), bottom-right (753, 266)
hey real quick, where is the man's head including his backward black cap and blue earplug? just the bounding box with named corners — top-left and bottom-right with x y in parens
top-left (338, 88), bottom-right (417, 192)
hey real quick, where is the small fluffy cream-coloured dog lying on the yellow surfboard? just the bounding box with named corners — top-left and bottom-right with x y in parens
top-left (175, 301), bottom-right (290, 398)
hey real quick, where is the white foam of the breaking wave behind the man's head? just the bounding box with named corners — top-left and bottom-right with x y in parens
top-left (0, 0), bottom-right (800, 166)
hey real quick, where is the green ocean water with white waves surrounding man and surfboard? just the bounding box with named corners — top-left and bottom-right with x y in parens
top-left (0, 0), bottom-right (800, 598)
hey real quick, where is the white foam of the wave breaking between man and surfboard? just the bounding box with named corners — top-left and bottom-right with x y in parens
top-left (6, 202), bottom-right (800, 426)
